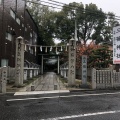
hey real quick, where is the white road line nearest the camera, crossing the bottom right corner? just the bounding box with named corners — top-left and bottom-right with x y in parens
top-left (40, 110), bottom-right (120, 120)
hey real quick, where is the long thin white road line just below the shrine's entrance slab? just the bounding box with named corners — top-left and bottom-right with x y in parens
top-left (6, 92), bottom-right (120, 101)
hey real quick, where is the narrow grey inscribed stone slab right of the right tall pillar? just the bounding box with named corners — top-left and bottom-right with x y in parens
top-left (82, 55), bottom-right (87, 85)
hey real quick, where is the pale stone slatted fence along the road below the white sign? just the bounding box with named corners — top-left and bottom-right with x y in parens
top-left (92, 68), bottom-right (120, 89)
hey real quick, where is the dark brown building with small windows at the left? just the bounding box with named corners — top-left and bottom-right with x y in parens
top-left (0, 0), bottom-right (38, 67)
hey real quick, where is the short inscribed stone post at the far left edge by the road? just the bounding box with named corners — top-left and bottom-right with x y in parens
top-left (0, 67), bottom-right (7, 93)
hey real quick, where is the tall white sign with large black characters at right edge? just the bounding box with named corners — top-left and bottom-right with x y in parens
top-left (113, 26), bottom-right (120, 64)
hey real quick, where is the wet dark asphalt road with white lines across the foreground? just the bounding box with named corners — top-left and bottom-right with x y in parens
top-left (0, 91), bottom-right (120, 120)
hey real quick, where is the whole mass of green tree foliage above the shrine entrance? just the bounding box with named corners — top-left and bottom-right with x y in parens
top-left (29, 0), bottom-right (119, 45)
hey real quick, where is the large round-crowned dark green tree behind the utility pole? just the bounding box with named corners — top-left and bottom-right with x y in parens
top-left (56, 2), bottom-right (106, 44)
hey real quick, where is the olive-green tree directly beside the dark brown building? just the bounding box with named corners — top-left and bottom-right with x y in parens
top-left (28, 0), bottom-right (55, 45)
